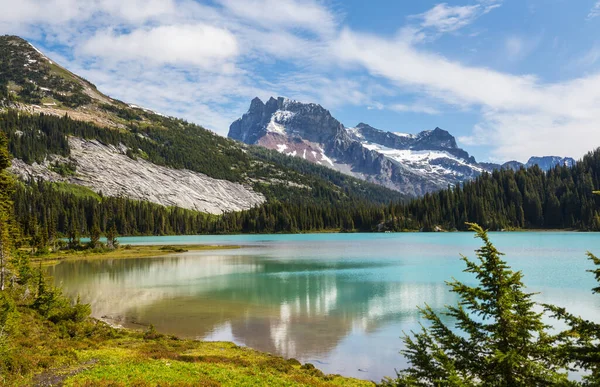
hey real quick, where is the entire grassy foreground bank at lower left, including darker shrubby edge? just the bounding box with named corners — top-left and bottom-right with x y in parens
top-left (0, 308), bottom-right (374, 387)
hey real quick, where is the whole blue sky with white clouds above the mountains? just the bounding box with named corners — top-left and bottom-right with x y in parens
top-left (0, 0), bottom-right (600, 161)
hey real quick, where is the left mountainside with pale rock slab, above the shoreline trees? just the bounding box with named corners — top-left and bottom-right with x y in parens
top-left (0, 36), bottom-right (402, 214)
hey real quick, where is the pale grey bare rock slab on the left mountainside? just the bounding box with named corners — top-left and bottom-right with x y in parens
top-left (12, 137), bottom-right (265, 214)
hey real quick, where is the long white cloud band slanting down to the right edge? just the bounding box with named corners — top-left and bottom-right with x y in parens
top-left (335, 29), bottom-right (600, 160)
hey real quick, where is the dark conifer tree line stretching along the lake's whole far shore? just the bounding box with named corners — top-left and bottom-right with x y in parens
top-left (12, 150), bottom-right (600, 244)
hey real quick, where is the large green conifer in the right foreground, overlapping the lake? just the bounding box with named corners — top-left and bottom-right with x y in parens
top-left (387, 224), bottom-right (569, 387)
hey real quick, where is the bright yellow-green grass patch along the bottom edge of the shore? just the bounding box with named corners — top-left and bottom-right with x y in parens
top-left (64, 337), bottom-right (373, 386)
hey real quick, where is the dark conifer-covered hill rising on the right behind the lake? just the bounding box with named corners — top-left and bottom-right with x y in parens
top-left (384, 149), bottom-right (600, 231)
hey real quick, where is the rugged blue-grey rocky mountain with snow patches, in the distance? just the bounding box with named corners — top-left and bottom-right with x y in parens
top-left (228, 97), bottom-right (493, 196)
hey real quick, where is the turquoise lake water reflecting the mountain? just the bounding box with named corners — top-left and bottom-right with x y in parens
top-left (49, 232), bottom-right (600, 381)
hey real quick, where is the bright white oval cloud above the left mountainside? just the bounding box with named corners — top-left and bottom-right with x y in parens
top-left (81, 24), bottom-right (239, 68)
